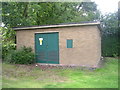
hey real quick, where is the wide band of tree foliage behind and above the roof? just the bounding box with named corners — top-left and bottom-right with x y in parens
top-left (2, 2), bottom-right (99, 27)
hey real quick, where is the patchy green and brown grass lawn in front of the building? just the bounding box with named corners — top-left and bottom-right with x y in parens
top-left (2, 58), bottom-right (118, 88)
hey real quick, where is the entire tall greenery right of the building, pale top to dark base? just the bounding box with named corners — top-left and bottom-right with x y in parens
top-left (101, 12), bottom-right (120, 56)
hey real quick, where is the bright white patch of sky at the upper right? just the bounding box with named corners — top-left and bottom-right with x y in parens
top-left (91, 0), bottom-right (120, 14)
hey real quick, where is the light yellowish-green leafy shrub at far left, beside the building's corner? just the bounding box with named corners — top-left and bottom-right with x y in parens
top-left (0, 25), bottom-right (16, 60)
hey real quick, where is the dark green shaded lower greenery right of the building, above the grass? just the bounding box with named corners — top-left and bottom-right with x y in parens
top-left (102, 35), bottom-right (120, 57)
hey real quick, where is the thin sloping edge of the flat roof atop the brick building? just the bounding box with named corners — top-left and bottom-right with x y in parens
top-left (13, 22), bottom-right (100, 30)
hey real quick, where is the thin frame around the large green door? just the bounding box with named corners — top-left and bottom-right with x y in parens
top-left (34, 31), bottom-right (60, 64)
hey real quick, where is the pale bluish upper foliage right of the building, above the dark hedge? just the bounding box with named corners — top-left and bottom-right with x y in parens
top-left (101, 12), bottom-right (118, 35)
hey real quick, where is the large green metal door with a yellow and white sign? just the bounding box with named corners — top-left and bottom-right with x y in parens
top-left (35, 33), bottom-right (59, 64)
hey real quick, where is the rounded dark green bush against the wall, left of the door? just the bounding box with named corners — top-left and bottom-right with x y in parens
top-left (6, 47), bottom-right (35, 64)
